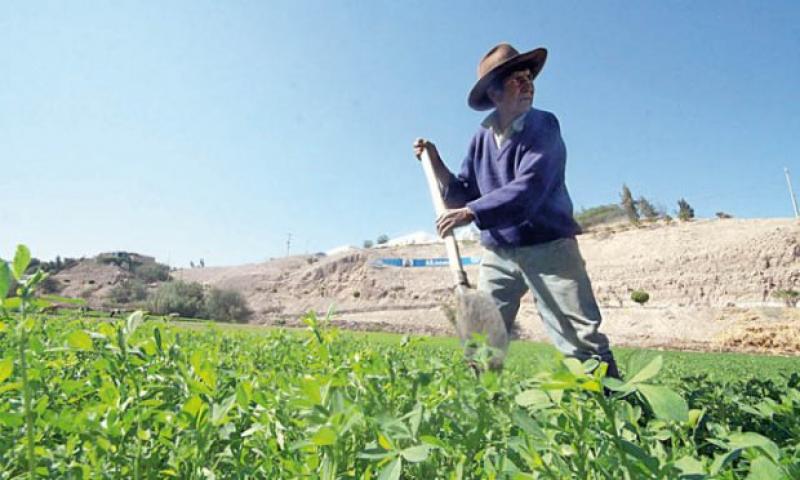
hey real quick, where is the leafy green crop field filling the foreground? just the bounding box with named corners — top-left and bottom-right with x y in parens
top-left (0, 247), bottom-right (800, 479)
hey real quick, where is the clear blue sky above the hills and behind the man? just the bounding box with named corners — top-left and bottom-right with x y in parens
top-left (0, 0), bottom-right (800, 266)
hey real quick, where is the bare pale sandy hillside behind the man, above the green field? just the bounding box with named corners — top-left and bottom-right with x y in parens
top-left (166, 219), bottom-right (800, 353)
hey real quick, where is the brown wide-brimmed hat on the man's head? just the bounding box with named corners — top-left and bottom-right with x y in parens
top-left (467, 43), bottom-right (547, 110)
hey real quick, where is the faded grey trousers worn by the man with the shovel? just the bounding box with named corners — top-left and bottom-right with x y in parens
top-left (478, 238), bottom-right (613, 363)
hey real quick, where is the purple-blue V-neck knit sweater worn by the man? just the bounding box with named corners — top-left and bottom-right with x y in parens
top-left (444, 108), bottom-right (580, 248)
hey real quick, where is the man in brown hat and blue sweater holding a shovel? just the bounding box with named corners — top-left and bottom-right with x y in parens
top-left (414, 43), bottom-right (619, 378)
